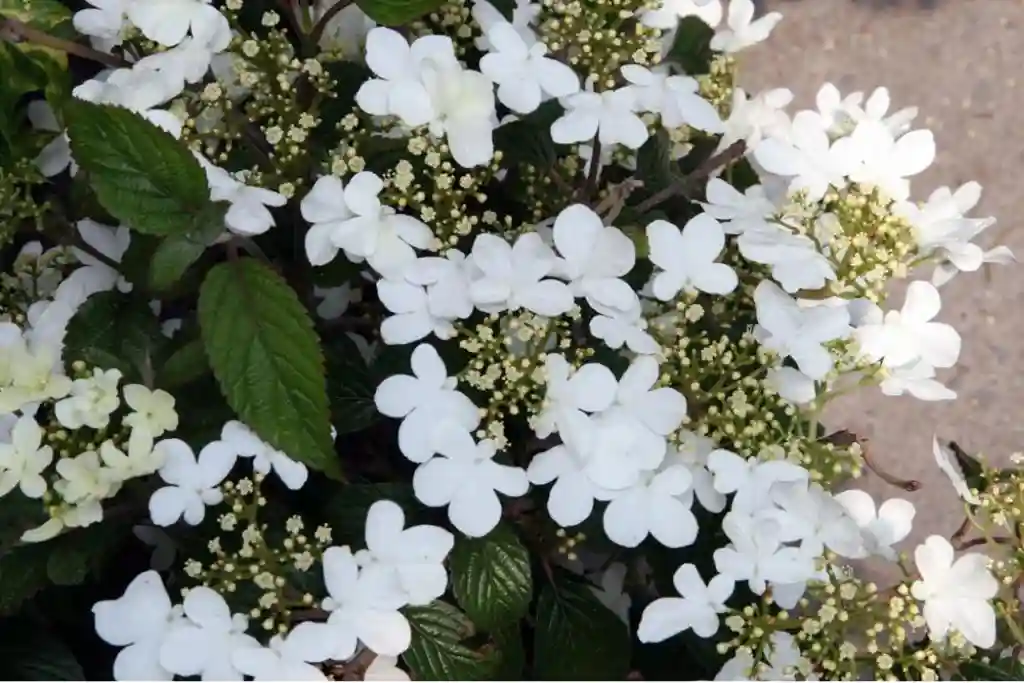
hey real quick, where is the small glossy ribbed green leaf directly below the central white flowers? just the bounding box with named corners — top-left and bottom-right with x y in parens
top-left (449, 523), bottom-right (534, 630)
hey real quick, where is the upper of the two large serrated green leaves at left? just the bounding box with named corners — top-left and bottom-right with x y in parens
top-left (66, 99), bottom-right (210, 236)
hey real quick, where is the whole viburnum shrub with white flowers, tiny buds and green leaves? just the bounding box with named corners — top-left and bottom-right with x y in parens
top-left (0, 0), bottom-right (1024, 680)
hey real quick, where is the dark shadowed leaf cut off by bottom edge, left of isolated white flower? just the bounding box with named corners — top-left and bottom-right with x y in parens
top-left (534, 572), bottom-right (630, 681)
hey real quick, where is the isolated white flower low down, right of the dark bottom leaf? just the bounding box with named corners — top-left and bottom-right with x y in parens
top-left (637, 563), bottom-right (735, 643)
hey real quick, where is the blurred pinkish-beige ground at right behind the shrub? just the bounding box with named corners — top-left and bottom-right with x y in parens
top-left (740, 0), bottom-right (1024, 557)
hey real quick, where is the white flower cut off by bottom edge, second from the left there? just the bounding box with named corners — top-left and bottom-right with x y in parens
top-left (160, 586), bottom-right (260, 681)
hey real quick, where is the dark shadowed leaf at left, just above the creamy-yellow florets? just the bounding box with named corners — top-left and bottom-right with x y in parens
top-left (65, 291), bottom-right (165, 379)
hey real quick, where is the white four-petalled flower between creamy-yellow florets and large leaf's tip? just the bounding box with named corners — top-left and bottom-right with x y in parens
top-left (150, 438), bottom-right (236, 526)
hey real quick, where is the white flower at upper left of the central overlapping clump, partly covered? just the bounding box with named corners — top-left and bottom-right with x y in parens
top-left (530, 353), bottom-right (617, 438)
